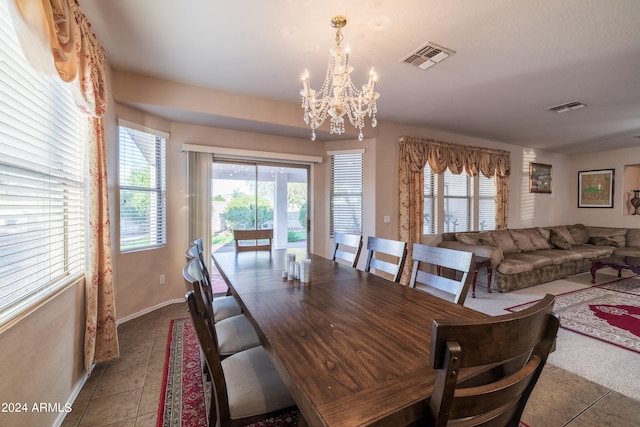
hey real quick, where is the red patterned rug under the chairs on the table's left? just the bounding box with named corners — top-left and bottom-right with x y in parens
top-left (157, 319), bottom-right (298, 427)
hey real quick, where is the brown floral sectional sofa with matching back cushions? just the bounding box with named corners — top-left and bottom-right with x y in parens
top-left (438, 224), bottom-right (640, 292)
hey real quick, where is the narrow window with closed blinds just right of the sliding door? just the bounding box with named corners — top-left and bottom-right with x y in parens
top-left (329, 152), bottom-right (363, 237)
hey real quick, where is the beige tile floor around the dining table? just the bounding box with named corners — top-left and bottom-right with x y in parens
top-left (63, 272), bottom-right (640, 427)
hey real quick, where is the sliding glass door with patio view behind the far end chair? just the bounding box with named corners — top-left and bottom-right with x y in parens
top-left (211, 161), bottom-right (309, 252)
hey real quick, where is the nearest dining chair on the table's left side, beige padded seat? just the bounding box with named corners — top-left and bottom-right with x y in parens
top-left (186, 291), bottom-right (296, 427)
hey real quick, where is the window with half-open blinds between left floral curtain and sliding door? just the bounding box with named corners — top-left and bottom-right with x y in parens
top-left (119, 122), bottom-right (166, 252)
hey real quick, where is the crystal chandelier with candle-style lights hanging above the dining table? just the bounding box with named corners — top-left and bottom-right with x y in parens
top-left (300, 16), bottom-right (380, 141)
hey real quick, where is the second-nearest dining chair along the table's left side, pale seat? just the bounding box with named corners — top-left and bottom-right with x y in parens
top-left (183, 259), bottom-right (260, 357)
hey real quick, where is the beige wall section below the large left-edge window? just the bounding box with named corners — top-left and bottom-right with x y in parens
top-left (0, 280), bottom-right (85, 427)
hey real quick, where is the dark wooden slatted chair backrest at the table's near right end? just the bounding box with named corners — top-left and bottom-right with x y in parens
top-left (429, 294), bottom-right (559, 426)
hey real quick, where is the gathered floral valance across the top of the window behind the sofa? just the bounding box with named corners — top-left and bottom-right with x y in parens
top-left (400, 136), bottom-right (511, 178)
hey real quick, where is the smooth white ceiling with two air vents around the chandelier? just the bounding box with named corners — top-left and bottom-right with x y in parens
top-left (80, 0), bottom-right (640, 154)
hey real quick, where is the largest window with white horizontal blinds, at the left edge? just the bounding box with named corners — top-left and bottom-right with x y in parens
top-left (0, 2), bottom-right (87, 320)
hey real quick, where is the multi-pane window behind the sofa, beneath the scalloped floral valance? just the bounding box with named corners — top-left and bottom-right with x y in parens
top-left (423, 165), bottom-right (495, 234)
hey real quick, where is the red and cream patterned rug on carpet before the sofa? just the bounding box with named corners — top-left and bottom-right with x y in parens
top-left (507, 277), bottom-right (640, 353)
